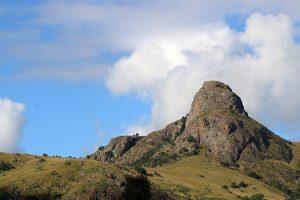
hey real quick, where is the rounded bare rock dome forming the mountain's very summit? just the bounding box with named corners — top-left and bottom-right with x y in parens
top-left (187, 81), bottom-right (247, 122)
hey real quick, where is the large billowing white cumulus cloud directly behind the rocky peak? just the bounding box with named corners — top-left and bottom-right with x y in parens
top-left (106, 13), bottom-right (300, 138)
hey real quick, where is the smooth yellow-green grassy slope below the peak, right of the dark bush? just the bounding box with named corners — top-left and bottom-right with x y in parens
top-left (147, 150), bottom-right (285, 199)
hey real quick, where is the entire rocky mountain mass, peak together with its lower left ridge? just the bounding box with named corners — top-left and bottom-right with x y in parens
top-left (92, 81), bottom-right (293, 166)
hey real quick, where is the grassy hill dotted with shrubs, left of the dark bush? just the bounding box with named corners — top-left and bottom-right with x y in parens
top-left (0, 153), bottom-right (131, 199)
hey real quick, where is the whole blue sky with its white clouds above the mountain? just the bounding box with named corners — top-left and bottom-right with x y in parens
top-left (0, 0), bottom-right (300, 156)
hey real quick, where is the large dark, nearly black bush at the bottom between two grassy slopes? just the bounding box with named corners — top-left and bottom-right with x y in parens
top-left (122, 175), bottom-right (151, 200)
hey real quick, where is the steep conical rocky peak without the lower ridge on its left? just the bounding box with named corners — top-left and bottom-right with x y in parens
top-left (185, 81), bottom-right (292, 164)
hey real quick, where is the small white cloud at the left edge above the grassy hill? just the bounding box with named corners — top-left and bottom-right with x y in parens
top-left (0, 98), bottom-right (25, 152)
